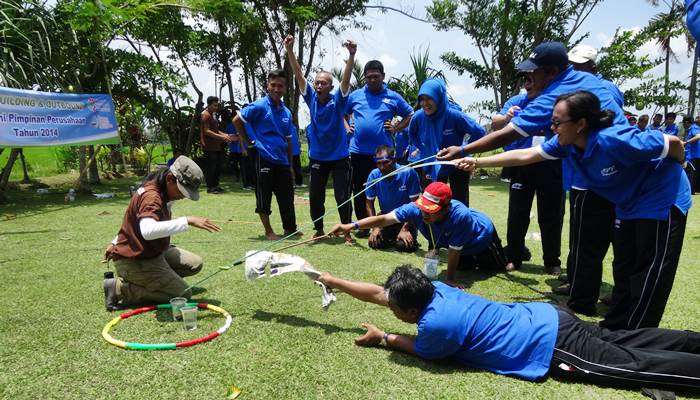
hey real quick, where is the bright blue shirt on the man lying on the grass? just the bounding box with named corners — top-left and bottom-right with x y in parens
top-left (415, 281), bottom-right (559, 381)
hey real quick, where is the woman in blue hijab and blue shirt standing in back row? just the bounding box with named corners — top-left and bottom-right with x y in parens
top-left (409, 79), bottom-right (486, 206)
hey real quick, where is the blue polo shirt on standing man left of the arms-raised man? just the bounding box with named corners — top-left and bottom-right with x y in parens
top-left (239, 96), bottom-right (294, 166)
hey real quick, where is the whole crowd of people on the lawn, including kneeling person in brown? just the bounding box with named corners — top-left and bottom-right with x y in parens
top-left (104, 6), bottom-right (700, 398)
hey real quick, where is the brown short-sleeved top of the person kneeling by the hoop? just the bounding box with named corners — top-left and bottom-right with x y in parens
top-left (112, 181), bottom-right (170, 260)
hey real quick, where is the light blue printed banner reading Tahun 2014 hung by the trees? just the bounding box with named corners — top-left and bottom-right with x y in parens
top-left (0, 87), bottom-right (119, 147)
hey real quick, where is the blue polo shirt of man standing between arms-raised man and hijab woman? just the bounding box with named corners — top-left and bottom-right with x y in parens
top-left (345, 84), bottom-right (413, 155)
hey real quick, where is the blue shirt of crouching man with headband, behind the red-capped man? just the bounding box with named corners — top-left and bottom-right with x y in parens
top-left (365, 164), bottom-right (421, 214)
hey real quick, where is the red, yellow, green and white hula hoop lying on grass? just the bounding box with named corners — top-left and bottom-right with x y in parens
top-left (102, 303), bottom-right (233, 350)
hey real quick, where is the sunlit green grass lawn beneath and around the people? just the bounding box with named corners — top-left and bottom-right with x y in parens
top-left (0, 173), bottom-right (700, 400)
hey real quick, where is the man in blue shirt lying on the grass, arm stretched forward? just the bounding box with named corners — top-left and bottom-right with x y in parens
top-left (319, 265), bottom-right (700, 391)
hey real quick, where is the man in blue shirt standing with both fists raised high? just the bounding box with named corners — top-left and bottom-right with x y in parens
top-left (284, 35), bottom-right (357, 244)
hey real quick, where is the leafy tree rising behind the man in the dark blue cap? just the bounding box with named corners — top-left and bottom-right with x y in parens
top-left (427, 0), bottom-right (602, 107)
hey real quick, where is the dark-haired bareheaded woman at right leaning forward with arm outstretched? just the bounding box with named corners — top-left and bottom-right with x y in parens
top-left (456, 91), bottom-right (692, 330)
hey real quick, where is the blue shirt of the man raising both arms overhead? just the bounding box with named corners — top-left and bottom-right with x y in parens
top-left (302, 82), bottom-right (348, 161)
